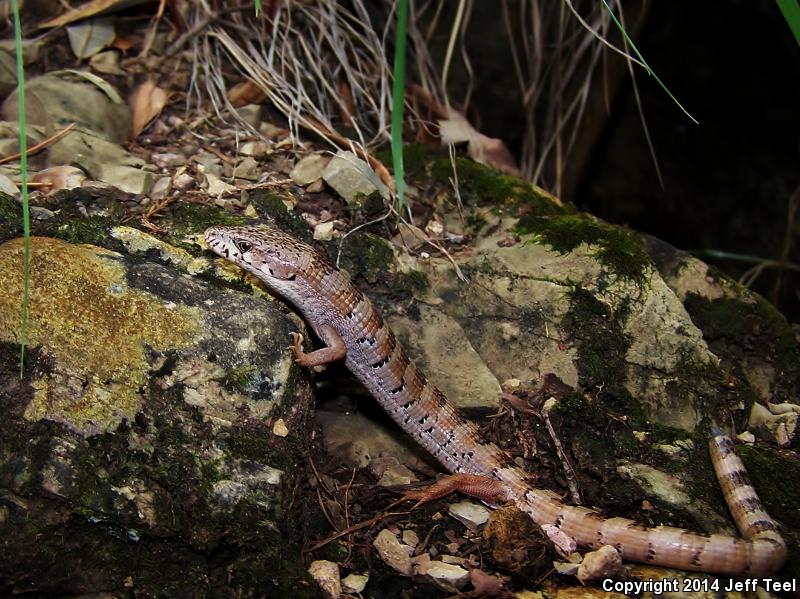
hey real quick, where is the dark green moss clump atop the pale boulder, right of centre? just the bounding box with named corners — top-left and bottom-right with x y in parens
top-left (517, 214), bottom-right (651, 281)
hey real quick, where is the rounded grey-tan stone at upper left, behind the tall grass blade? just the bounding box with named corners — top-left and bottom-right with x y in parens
top-left (3, 71), bottom-right (131, 144)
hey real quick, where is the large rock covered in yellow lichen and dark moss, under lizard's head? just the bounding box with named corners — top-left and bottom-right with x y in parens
top-left (0, 234), bottom-right (313, 596)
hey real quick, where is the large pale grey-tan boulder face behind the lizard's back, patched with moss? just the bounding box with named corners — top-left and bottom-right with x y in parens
top-left (388, 216), bottom-right (718, 431)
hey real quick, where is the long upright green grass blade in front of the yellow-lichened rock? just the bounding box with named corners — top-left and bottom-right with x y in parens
top-left (11, 0), bottom-right (31, 378)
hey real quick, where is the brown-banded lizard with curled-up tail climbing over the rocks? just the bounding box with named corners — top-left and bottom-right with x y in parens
top-left (205, 226), bottom-right (786, 576)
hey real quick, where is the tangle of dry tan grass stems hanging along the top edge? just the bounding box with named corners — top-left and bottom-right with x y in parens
top-left (191, 0), bottom-right (640, 194)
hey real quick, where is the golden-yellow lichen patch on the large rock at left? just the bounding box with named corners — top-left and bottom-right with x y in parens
top-left (0, 237), bottom-right (199, 434)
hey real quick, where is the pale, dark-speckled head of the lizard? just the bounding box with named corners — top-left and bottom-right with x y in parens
top-left (205, 226), bottom-right (324, 298)
